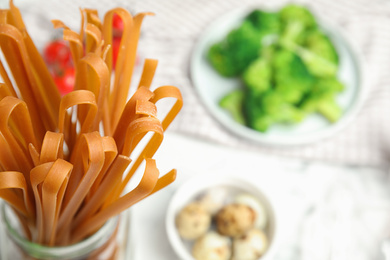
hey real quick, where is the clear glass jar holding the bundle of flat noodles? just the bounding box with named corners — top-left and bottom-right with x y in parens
top-left (0, 201), bottom-right (132, 260)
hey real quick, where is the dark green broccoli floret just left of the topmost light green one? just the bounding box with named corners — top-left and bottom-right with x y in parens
top-left (246, 9), bottom-right (281, 35)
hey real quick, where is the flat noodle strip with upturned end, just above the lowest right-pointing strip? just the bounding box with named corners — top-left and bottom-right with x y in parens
top-left (72, 158), bottom-right (159, 242)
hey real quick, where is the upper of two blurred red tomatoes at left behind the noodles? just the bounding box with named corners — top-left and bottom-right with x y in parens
top-left (44, 40), bottom-right (71, 67)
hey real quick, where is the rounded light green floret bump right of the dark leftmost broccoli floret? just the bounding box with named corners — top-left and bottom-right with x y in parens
top-left (242, 57), bottom-right (272, 94)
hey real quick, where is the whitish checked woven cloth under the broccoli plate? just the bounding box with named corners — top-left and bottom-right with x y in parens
top-left (15, 0), bottom-right (390, 166)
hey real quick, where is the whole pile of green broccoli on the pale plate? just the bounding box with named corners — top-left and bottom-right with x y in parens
top-left (208, 4), bottom-right (344, 132)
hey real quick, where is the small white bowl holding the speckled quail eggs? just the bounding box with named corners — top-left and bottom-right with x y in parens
top-left (165, 174), bottom-right (279, 260)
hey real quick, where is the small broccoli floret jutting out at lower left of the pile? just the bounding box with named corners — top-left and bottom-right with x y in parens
top-left (219, 90), bottom-right (245, 125)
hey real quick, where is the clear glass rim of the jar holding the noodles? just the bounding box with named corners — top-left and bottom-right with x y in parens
top-left (0, 200), bottom-right (118, 259)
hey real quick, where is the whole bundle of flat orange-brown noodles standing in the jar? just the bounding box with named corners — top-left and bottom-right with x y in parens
top-left (0, 1), bottom-right (182, 246)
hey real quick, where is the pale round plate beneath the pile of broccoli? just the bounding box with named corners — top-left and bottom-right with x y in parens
top-left (190, 8), bottom-right (363, 145)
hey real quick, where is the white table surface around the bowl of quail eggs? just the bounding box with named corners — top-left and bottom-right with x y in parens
top-left (131, 131), bottom-right (390, 260)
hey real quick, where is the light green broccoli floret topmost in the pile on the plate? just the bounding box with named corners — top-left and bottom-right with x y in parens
top-left (279, 4), bottom-right (317, 44)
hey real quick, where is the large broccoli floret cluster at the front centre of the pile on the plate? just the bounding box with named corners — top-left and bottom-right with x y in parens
top-left (243, 47), bottom-right (315, 132)
